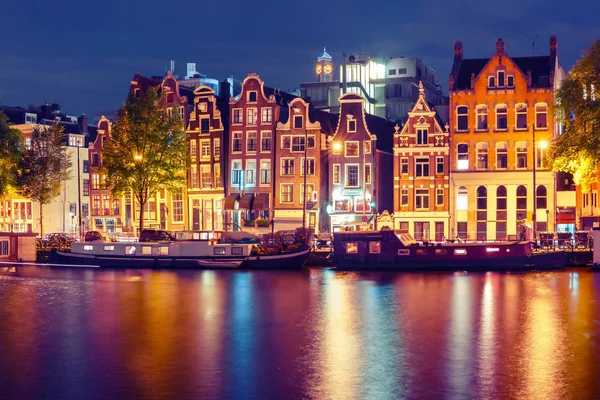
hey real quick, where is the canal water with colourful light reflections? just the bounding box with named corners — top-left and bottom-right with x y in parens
top-left (0, 264), bottom-right (600, 399)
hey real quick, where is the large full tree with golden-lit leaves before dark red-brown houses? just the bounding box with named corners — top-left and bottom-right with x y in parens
top-left (102, 88), bottom-right (187, 232)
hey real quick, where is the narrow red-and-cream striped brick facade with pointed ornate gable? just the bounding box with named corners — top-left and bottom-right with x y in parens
top-left (393, 82), bottom-right (450, 242)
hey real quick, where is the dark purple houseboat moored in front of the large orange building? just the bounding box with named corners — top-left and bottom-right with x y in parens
top-left (333, 230), bottom-right (565, 271)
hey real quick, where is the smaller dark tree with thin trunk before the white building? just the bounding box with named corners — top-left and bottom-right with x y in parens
top-left (17, 121), bottom-right (72, 236)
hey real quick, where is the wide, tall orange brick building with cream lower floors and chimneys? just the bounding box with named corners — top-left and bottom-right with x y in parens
top-left (449, 37), bottom-right (564, 240)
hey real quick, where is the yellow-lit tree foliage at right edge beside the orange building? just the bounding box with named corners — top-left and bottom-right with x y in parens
top-left (548, 40), bottom-right (600, 192)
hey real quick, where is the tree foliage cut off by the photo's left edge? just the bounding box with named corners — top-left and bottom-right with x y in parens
top-left (0, 111), bottom-right (21, 197)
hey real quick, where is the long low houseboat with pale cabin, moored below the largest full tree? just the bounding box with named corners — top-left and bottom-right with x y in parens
top-left (49, 231), bottom-right (309, 269)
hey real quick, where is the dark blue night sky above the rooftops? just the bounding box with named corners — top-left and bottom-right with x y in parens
top-left (0, 0), bottom-right (600, 119)
